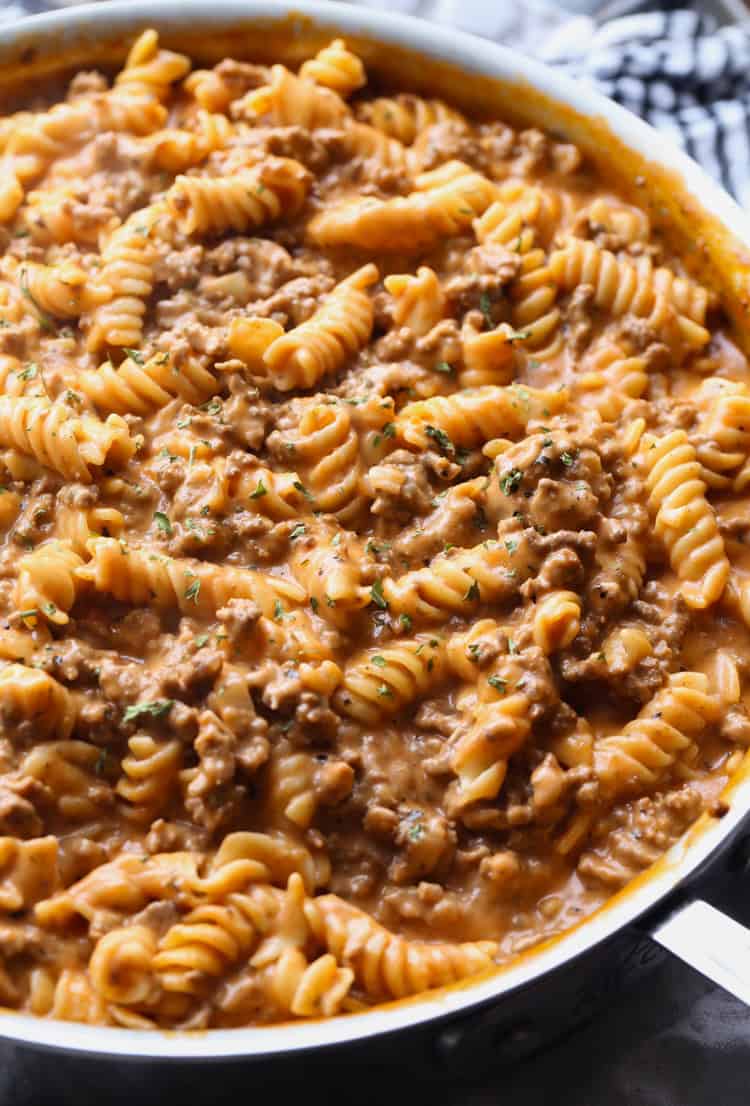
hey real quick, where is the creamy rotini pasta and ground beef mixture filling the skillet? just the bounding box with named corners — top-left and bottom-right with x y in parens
top-left (0, 31), bottom-right (750, 1027)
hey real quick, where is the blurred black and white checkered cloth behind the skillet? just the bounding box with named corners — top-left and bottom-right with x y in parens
top-left (0, 0), bottom-right (750, 209)
